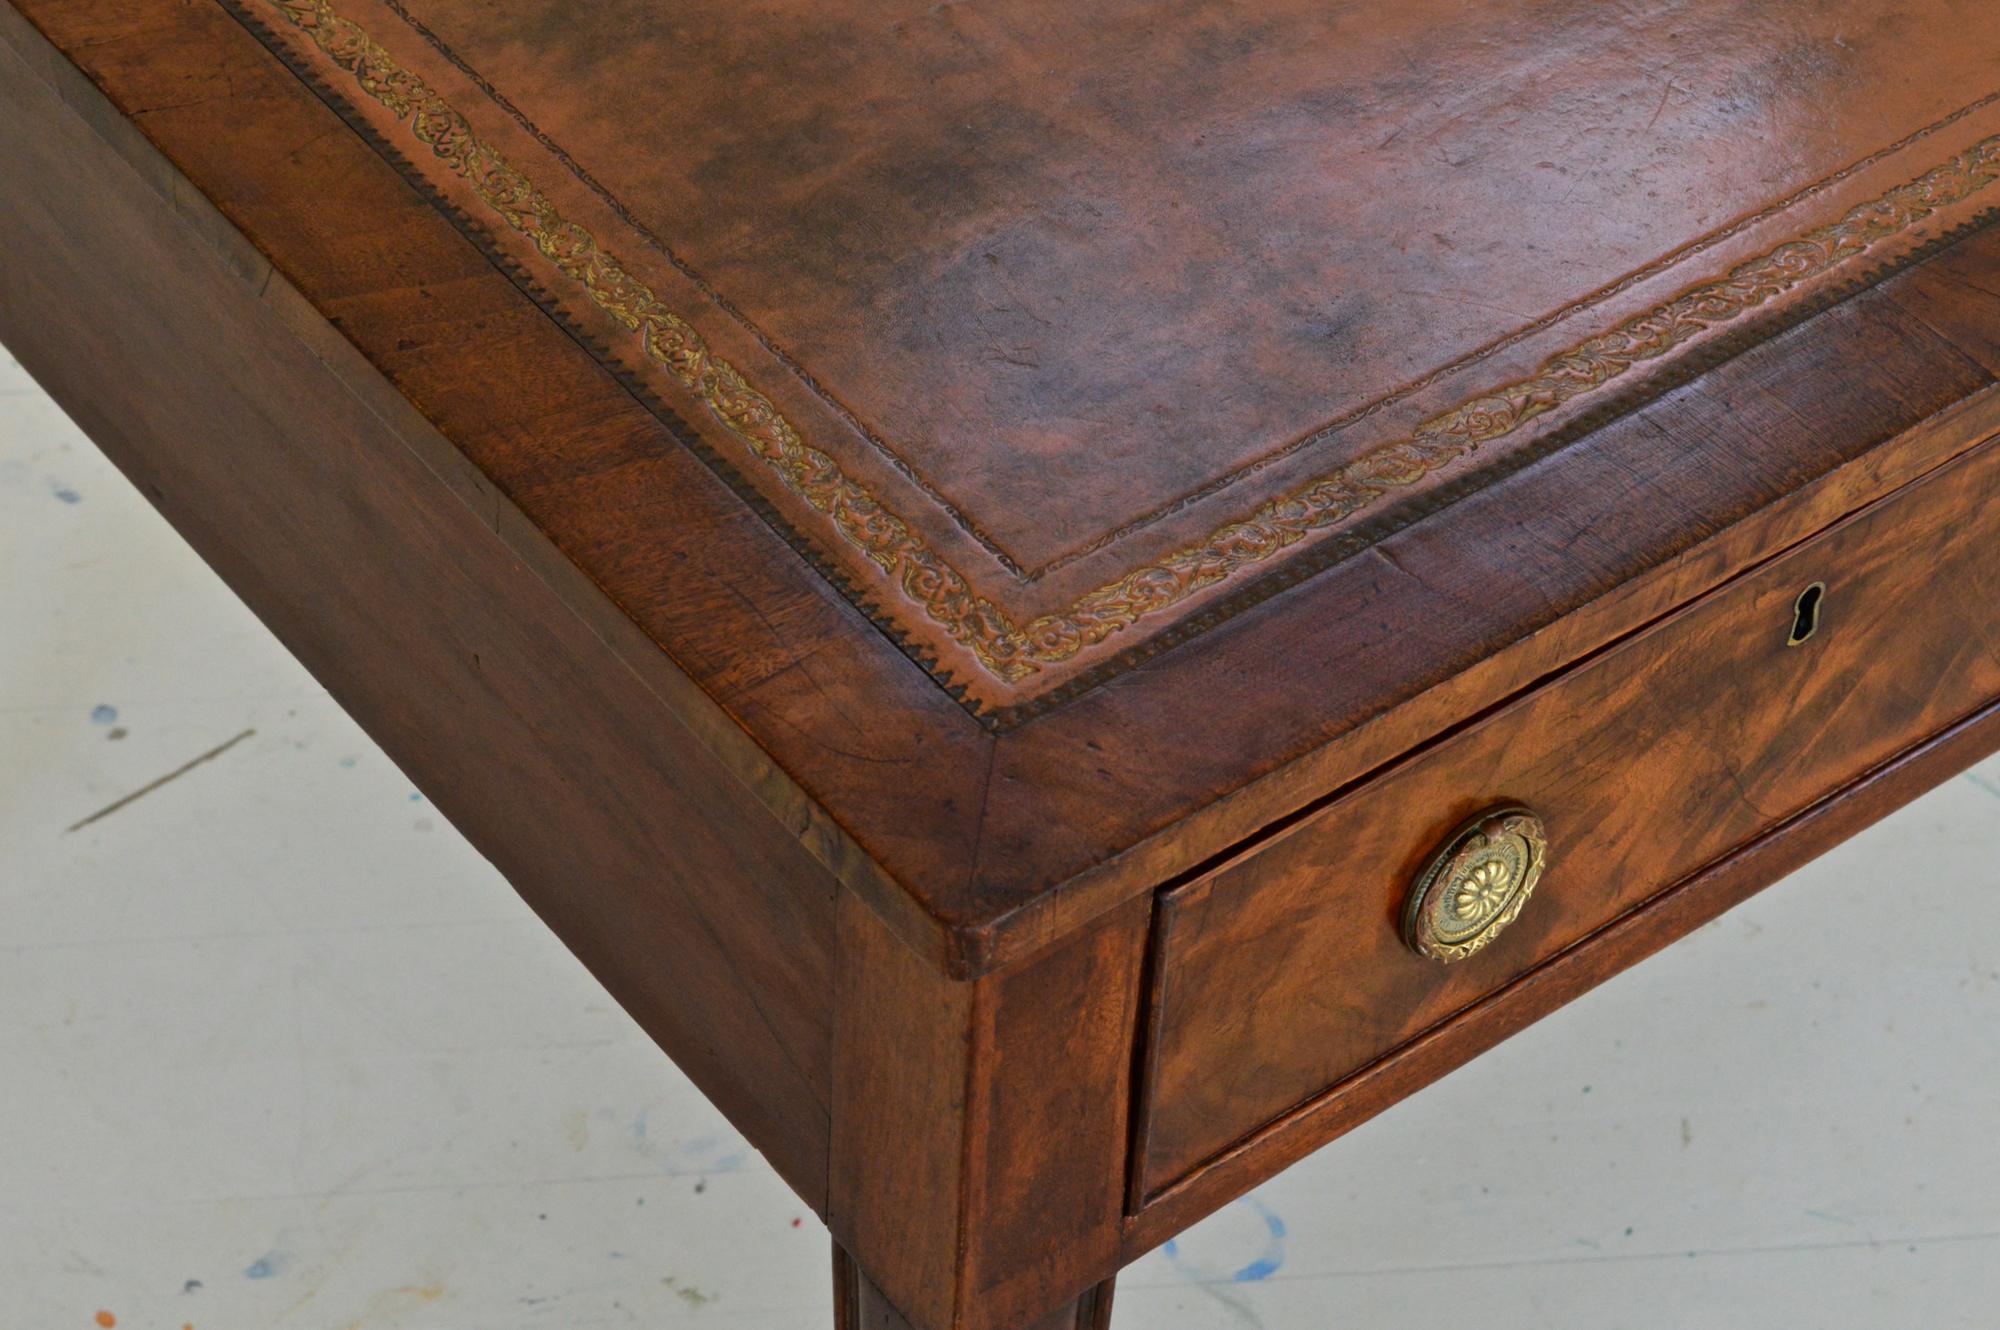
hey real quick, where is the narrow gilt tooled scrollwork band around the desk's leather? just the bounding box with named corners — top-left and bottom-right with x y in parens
top-left (246, 0), bottom-right (2000, 700)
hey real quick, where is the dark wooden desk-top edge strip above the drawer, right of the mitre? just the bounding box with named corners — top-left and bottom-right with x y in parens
top-left (974, 294), bottom-right (2000, 976)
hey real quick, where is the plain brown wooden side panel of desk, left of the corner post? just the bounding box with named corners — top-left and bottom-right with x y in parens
top-left (0, 0), bottom-right (836, 1210)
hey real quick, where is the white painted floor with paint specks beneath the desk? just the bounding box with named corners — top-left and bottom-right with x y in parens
top-left (0, 344), bottom-right (2000, 1330)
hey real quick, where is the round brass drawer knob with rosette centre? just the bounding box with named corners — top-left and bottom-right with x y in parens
top-left (1402, 806), bottom-right (1548, 964)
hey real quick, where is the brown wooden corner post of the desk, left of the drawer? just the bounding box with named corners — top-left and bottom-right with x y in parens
top-left (828, 898), bottom-right (1152, 1330)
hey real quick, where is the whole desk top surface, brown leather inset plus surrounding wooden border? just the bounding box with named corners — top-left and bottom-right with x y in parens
top-left (18, 0), bottom-right (2000, 968)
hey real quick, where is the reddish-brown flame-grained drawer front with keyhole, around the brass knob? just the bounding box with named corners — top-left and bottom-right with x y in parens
top-left (1136, 430), bottom-right (2000, 1202)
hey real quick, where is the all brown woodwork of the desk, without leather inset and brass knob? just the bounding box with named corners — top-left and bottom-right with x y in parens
top-left (11, 0), bottom-right (2000, 1330)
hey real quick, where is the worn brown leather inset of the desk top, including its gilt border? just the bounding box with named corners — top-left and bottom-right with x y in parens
top-left (244, 0), bottom-right (2000, 708)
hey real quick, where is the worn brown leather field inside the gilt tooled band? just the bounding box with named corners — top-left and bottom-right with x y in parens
top-left (364, 0), bottom-right (2000, 568)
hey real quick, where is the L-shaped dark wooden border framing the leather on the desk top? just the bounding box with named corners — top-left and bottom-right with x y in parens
top-left (11, 0), bottom-right (2000, 974)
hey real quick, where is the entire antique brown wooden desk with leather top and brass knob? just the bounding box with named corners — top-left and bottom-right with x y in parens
top-left (0, 0), bottom-right (2000, 1330)
